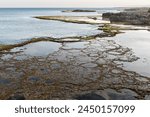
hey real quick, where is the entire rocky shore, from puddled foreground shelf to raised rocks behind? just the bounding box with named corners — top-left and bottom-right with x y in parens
top-left (0, 9), bottom-right (150, 100)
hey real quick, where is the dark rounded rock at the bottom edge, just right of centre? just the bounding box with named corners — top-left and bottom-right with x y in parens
top-left (75, 93), bottom-right (105, 100)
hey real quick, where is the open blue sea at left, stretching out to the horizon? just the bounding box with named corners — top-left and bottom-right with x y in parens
top-left (0, 8), bottom-right (120, 44)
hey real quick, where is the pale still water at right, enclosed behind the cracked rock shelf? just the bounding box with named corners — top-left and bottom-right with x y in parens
top-left (109, 30), bottom-right (150, 77)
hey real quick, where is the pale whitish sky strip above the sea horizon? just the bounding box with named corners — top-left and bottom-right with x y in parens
top-left (0, 0), bottom-right (150, 8)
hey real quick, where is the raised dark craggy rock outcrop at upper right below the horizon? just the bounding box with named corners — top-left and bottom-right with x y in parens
top-left (102, 8), bottom-right (150, 26)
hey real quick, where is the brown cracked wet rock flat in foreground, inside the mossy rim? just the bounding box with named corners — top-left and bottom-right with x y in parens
top-left (0, 37), bottom-right (150, 100)
